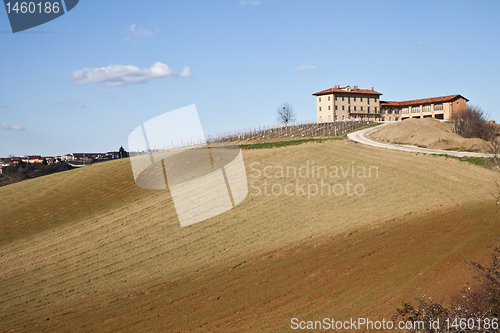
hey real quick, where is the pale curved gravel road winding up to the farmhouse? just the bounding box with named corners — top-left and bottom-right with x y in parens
top-left (347, 123), bottom-right (493, 158)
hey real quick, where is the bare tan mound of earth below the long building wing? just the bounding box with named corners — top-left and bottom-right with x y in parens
top-left (370, 118), bottom-right (486, 151)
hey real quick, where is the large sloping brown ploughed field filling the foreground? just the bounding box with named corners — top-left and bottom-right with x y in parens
top-left (0, 140), bottom-right (500, 332)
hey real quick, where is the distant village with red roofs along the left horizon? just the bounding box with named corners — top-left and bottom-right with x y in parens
top-left (0, 150), bottom-right (129, 174)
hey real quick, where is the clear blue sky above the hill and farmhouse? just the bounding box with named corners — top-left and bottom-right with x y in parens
top-left (0, 0), bottom-right (500, 157)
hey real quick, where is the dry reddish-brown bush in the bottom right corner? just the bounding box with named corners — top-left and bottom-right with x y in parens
top-left (393, 247), bottom-right (500, 332)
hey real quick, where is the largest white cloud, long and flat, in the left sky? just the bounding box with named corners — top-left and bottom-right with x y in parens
top-left (71, 62), bottom-right (191, 86)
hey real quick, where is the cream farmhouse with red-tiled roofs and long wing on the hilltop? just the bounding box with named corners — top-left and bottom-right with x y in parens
top-left (313, 85), bottom-right (469, 123)
